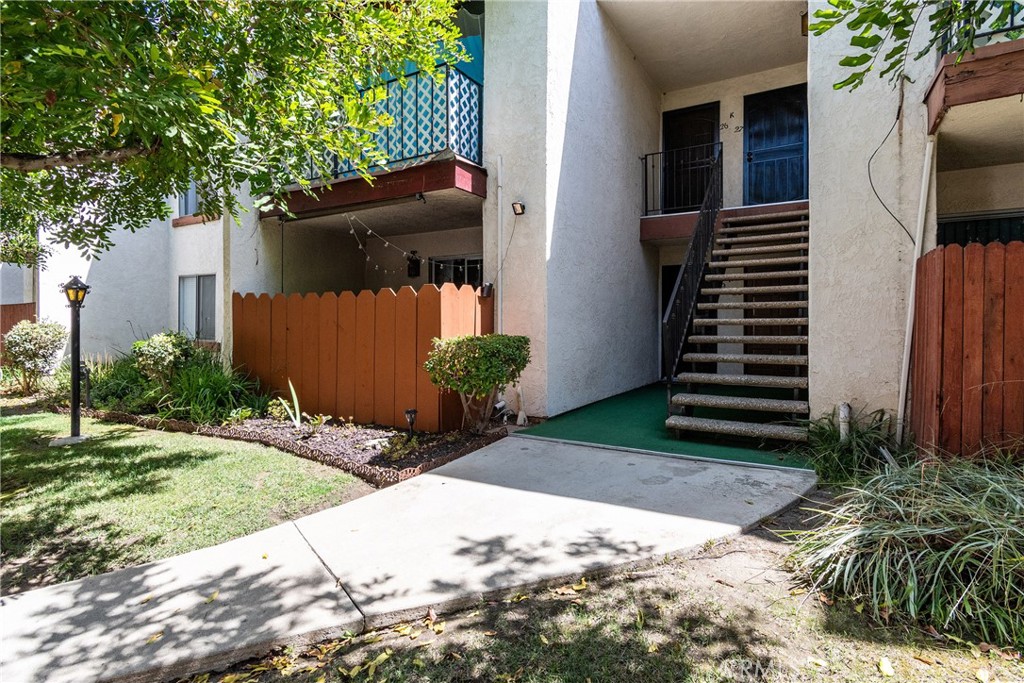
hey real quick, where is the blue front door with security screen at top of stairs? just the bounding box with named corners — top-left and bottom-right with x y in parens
top-left (743, 84), bottom-right (807, 205)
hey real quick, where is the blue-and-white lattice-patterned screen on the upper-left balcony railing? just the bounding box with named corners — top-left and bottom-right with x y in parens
top-left (305, 65), bottom-right (483, 181)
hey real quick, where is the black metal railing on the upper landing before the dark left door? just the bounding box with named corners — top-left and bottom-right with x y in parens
top-left (641, 142), bottom-right (722, 216)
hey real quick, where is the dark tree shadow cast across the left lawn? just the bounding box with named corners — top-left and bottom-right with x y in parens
top-left (0, 418), bottom-right (213, 595)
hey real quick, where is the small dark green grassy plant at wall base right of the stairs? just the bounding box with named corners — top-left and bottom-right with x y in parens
top-left (797, 410), bottom-right (914, 483)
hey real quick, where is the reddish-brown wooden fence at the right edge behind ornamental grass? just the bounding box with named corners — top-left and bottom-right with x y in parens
top-left (910, 242), bottom-right (1024, 456)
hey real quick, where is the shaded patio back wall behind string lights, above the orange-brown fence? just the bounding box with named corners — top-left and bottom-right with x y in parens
top-left (364, 227), bottom-right (483, 291)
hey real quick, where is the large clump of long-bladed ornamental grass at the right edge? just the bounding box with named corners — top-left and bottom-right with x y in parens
top-left (791, 459), bottom-right (1024, 647)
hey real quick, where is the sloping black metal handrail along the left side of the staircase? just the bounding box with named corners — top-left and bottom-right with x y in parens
top-left (662, 147), bottom-right (722, 384)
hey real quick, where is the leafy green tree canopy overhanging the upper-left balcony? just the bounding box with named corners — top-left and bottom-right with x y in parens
top-left (0, 0), bottom-right (464, 263)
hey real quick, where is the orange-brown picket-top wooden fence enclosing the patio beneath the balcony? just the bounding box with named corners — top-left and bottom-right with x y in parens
top-left (232, 283), bottom-right (494, 431)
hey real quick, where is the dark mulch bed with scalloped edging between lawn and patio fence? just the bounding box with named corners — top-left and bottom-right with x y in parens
top-left (51, 408), bottom-right (507, 488)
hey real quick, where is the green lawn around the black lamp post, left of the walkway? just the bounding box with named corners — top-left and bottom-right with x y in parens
top-left (0, 413), bottom-right (369, 594)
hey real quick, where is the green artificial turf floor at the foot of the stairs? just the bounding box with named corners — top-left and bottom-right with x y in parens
top-left (519, 384), bottom-right (809, 469)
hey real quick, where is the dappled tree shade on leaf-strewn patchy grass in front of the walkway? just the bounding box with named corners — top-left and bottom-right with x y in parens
top-left (211, 593), bottom-right (778, 683)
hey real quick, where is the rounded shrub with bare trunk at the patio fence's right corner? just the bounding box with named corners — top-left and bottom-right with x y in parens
top-left (423, 335), bottom-right (529, 432)
